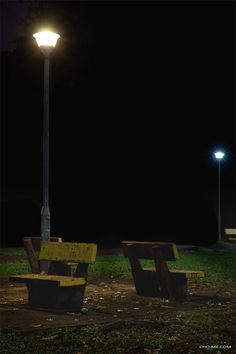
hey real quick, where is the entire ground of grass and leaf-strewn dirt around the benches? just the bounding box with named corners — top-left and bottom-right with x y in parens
top-left (1, 250), bottom-right (236, 354)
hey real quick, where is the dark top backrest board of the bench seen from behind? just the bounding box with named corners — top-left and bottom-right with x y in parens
top-left (122, 241), bottom-right (179, 261)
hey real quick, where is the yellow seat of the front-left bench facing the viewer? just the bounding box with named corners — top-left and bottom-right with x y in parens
top-left (9, 274), bottom-right (86, 287)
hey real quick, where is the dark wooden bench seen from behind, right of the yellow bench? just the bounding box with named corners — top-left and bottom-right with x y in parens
top-left (122, 241), bottom-right (204, 298)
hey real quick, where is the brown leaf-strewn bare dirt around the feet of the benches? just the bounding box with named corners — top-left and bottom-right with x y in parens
top-left (0, 277), bottom-right (236, 331)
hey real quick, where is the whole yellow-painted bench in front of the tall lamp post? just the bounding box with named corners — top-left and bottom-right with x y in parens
top-left (9, 242), bottom-right (97, 312)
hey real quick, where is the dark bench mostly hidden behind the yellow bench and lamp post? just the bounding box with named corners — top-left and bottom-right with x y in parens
top-left (23, 236), bottom-right (62, 274)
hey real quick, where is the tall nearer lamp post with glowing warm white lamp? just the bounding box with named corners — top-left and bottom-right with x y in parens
top-left (33, 31), bottom-right (60, 272)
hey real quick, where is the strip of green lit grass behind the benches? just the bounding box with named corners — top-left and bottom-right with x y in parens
top-left (0, 249), bottom-right (236, 288)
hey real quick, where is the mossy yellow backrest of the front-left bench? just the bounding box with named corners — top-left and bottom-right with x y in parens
top-left (39, 242), bottom-right (97, 263)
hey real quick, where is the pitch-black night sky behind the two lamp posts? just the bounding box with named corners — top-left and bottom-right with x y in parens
top-left (1, 1), bottom-right (236, 247)
